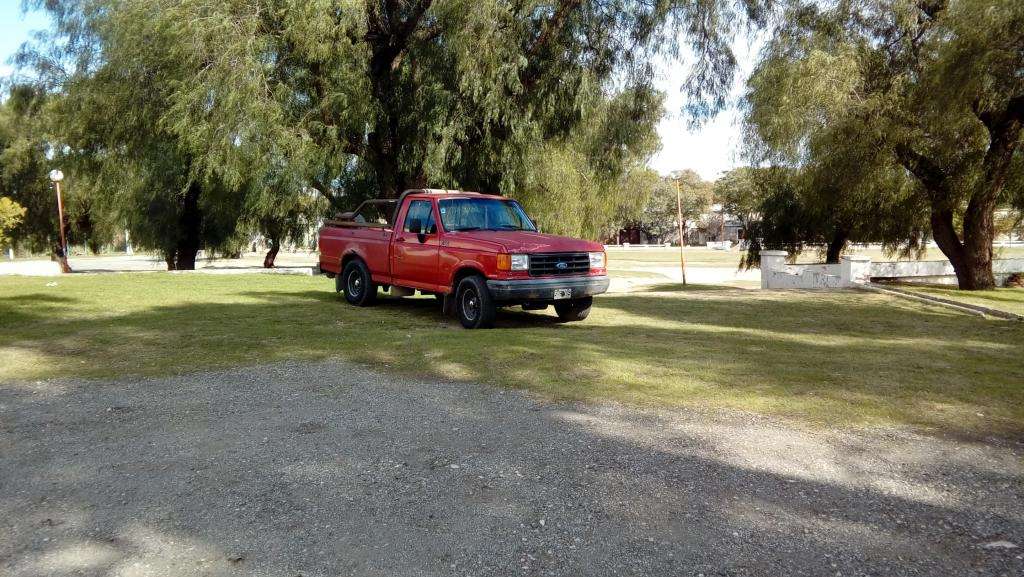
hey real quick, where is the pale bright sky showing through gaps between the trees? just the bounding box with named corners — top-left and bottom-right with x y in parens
top-left (0, 0), bottom-right (758, 180)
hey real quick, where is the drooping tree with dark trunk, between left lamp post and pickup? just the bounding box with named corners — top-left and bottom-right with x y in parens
top-left (17, 0), bottom-right (244, 270)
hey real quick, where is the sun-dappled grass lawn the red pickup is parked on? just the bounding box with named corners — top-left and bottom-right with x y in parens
top-left (0, 273), bottom-right (1024, 434)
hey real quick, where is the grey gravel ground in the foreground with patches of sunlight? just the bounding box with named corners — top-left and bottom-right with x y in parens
top-left (0, 362), bottom-right (1024, 577)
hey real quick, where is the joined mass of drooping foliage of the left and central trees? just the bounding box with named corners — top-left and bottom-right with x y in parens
top-left (6, 0), bottom-right (764, 259)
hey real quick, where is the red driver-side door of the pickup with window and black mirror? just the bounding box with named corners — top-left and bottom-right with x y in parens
top-left (391, 199), bottom-right (438, 290)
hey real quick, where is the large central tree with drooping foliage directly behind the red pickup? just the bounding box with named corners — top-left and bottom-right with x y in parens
top-left (132, 0), bottom-right (762, 202)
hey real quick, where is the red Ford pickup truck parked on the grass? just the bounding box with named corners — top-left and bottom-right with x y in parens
top-left (319, 190), bottom-right (608, 328)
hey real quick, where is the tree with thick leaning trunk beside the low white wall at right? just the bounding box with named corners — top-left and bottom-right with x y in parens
top-left (746, 0), bottom-right (1024, 289)
